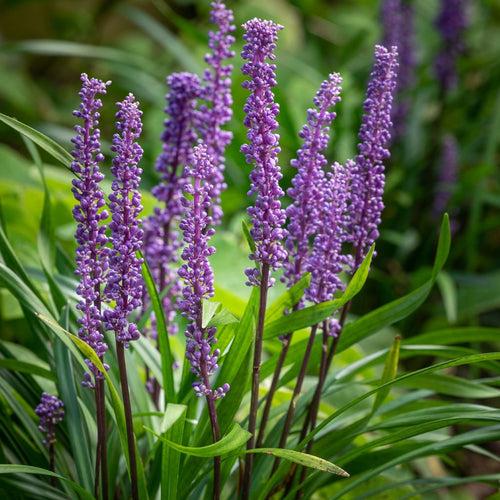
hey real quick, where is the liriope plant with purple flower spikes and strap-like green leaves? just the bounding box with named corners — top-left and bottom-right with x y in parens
top-left (0, 1), bottom-right (500, 499)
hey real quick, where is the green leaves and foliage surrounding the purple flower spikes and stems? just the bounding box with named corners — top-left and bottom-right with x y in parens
top-left (0, 0), bottom-right (500, 498)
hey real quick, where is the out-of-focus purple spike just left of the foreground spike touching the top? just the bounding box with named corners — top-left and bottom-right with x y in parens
top-left (143, 72), bottom-right (201, 335)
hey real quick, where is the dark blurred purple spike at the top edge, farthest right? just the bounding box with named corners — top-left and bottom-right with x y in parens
top-left (434, 0), bottom-right (468, 90)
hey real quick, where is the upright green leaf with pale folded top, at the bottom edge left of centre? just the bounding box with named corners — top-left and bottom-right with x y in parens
top-left (161, 403), bottom-right (187, 500)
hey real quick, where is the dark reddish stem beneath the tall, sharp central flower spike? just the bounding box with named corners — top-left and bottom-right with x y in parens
top-left (242, 264), bottom-right (269, 500)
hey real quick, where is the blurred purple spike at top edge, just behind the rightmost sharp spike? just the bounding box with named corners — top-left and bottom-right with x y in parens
top-left (381, 0), bottom-right (416, 137)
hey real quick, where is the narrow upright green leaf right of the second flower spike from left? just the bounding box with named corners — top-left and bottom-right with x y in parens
top-left (141, 255), bottom-right (177, 403)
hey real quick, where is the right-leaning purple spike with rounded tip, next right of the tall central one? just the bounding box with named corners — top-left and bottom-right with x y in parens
top-left (284, 73), bottom-right (342, 286)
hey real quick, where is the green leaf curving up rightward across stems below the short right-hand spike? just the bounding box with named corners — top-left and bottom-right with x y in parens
top-left (264, 246), bottom-right (374, 339)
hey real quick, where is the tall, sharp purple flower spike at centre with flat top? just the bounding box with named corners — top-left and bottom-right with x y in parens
top-left (241, 18), bottom-right (286, 286)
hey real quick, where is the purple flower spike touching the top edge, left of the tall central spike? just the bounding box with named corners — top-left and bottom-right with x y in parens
top-left (198, 0), bottom-right (236, 224)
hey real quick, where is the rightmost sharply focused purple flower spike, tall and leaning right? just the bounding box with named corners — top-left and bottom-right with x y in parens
top-left (349, 45), bottom-right (398, 270)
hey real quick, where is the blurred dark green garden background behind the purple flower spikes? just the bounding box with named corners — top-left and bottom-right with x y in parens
top-left (0, 0), bottom-right (500, 368)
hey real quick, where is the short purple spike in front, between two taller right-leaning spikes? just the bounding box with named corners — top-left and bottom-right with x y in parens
top-left (306, 160), bottom-right (353, 304)
